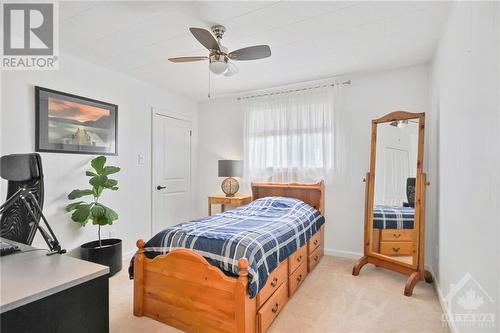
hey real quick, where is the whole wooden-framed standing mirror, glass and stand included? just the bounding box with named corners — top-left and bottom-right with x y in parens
top-left (352, 111), bottom-right (432, 296)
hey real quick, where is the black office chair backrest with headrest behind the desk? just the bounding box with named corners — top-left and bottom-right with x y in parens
top-left (0, 153), bottom-right (43, 245)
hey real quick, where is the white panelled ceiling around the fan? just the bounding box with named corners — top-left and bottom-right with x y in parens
top-left (59, 1), bottom-right (449, 100)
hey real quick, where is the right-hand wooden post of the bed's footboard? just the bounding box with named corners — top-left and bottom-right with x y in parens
top-left (234, 258), bottom-right (250, 333)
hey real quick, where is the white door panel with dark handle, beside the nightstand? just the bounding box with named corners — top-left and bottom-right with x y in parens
top-left (152, 113), bottom-right (191, 235)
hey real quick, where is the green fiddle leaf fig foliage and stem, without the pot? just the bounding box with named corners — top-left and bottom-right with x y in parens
top-left (66, 156), bottom-right (120, 246)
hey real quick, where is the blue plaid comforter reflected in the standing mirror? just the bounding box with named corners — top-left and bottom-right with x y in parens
top-left (373, 205), bottom-right (415, 229)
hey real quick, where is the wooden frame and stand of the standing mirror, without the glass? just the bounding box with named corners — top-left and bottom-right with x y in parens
top-left (352, 111), bottom-right (432, 296)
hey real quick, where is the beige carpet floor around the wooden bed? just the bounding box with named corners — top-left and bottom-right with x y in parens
top-left (109, 256), bottom-right (448, 333)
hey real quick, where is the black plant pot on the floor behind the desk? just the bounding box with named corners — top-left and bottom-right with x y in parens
top-left (80, 238), bottom-right (122, 276)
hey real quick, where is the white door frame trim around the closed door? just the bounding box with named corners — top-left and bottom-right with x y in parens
top-left (149, 106), bottom-right (194, 237)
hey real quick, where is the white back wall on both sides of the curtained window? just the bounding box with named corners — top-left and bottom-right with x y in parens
top-left (198, 65), bottom-right (436, 256)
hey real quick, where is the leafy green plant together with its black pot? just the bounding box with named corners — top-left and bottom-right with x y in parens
top-left (66, 156), bottom-right (122, 275)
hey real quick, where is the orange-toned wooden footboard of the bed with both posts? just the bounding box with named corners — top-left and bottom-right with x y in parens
top-left (134, 240), bottom-right (256, 333)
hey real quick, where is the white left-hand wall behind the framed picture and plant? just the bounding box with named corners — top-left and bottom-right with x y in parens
top-left (0, 55), bottom-right (197, 253)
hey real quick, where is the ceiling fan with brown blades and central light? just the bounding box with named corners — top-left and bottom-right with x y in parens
top-left (168, 25), bottom-right (271, 76)
